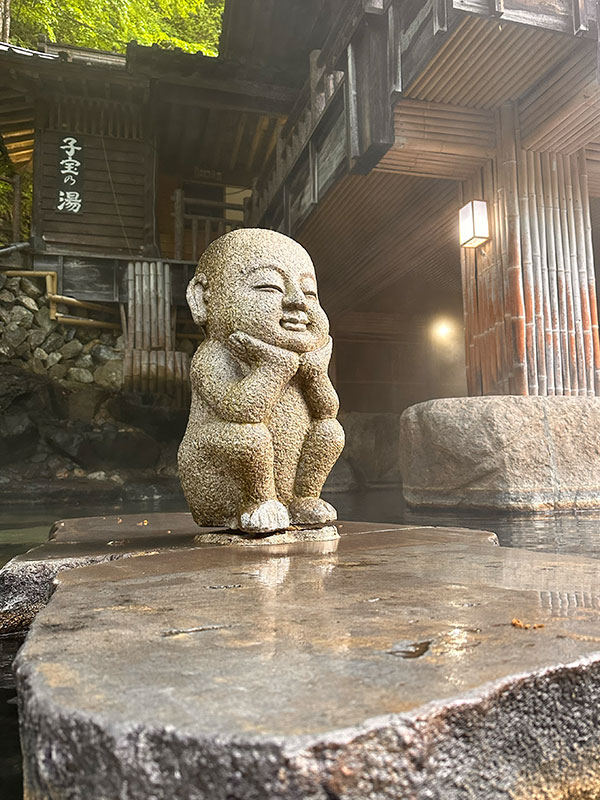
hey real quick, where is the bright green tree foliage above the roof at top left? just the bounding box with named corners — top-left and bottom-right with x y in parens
top-left (11, 0), bottom-right (225, 56)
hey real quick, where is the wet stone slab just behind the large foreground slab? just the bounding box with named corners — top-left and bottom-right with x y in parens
top-left (0, 512), bottom-right (497, 635)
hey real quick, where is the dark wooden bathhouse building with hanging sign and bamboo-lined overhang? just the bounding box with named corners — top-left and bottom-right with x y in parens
top-left (0, 0), bottom-right (600, 412)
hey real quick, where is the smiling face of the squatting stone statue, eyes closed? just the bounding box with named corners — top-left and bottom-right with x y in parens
top-left (208, 231), bottom-right (329, 353)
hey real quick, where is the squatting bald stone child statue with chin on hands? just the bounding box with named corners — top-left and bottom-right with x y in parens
top-left (178, 228), bottom-right (344, 533)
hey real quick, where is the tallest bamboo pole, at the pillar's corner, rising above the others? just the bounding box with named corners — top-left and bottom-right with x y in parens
top-left (500, 104), bottom-right (528, 395)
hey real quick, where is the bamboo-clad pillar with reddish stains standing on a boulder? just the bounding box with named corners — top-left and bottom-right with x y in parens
top-left (461, 105), bottom-right (600, 395)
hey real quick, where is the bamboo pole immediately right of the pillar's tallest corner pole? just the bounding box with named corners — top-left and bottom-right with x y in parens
top-left (518, 149), bottom-right (538, 395)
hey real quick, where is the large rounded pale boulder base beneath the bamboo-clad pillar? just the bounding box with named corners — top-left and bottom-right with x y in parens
top-left (400, 396), bottom-right (600, 511)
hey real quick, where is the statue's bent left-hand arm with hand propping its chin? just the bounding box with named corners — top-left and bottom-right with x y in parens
top-left (194, 334), bottom-right (298, 423)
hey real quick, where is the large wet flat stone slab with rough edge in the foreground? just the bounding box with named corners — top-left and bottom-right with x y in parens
top-left (16, 528), bottom-right (600, 800)
